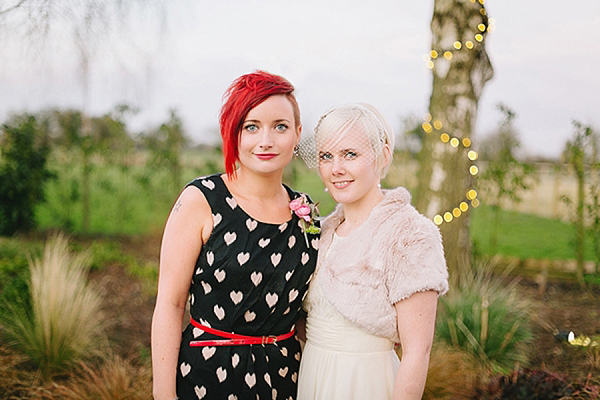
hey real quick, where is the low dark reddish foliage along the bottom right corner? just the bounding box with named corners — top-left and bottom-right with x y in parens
top-left (474, 369), bottom-right (600, 400)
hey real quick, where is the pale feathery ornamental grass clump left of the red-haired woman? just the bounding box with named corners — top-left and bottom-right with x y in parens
top-left (2, 235), bottom-right (106, 378)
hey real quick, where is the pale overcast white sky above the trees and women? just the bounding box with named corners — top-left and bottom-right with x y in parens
top-left (0, 0), bottom-right (600, 158)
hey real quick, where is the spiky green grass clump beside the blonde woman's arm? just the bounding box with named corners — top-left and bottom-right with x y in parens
top-left (436, 263), bottom-right (532, 370)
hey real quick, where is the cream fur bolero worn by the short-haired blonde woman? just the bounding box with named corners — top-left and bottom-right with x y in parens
top-left (316, 187), bottom-right (448, 342)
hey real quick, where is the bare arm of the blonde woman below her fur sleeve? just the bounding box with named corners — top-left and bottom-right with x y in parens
top-left (394, 291), bottom-right (438, 400)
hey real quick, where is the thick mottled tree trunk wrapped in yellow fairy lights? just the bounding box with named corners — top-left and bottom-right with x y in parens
top-left (415, 0), bottom-right (493, 274)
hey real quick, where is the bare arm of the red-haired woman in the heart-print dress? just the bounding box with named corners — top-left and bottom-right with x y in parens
top-left (151, 187), bottom-right (213, 400)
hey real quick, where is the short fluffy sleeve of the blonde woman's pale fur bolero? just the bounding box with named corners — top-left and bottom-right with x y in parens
top-left (385, 209), bottom-right (448, 304)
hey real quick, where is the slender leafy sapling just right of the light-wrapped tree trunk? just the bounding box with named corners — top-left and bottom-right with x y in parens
top-left (478, 104), bottom-right (535, 252)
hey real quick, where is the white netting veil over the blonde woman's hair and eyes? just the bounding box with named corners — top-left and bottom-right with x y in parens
top-left (298, 103), bottom-right (394, 173)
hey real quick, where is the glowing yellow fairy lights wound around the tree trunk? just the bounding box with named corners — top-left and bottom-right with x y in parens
top-left (421, 0), bottom-right (496, 225)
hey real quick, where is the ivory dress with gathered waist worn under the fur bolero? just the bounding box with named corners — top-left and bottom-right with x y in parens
top-left (298, 235), bottom-right (400, 400)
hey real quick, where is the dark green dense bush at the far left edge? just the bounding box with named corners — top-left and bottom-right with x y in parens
top-left (0, 115), bottom-right (52, 236)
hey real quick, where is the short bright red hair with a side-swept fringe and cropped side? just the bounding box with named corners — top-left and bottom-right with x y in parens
top-left (219, 71), bottom-right (300, 177)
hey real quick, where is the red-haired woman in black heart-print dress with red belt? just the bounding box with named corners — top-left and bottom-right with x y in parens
top-left (152, 71), bottom-right (318, 400)
